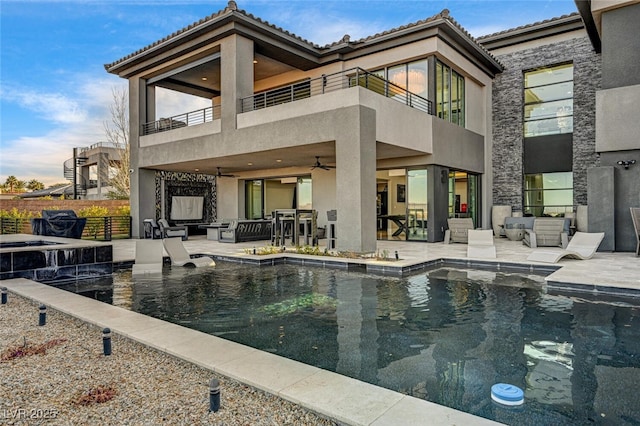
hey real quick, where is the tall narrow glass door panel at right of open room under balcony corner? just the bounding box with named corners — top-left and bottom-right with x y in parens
top-left (405, 169), bottom-right (427, 241)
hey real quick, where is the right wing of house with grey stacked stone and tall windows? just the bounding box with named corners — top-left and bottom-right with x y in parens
top-left (478, 0), bottom-right (640, 251)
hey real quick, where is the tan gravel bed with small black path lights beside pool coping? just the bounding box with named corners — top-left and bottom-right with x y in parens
top-left (0, 293), bottom-right (335, 425)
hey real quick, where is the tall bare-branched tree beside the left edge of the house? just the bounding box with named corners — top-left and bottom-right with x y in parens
top-left (104, 88), bottom-right (131, 200)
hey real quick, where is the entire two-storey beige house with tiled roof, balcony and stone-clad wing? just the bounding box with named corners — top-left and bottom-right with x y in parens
top-left (105, 1), bottom-right (640, 252)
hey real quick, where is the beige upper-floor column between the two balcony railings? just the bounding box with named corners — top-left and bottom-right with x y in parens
top-left (220, 35), bottom-right (254, 132)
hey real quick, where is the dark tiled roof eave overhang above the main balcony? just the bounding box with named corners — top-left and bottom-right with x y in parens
top-left (105, 2), bottom-right (503, 78)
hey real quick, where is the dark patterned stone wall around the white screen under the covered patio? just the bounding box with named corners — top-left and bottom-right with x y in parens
top-left (156, 171), bottom-right (217, 223)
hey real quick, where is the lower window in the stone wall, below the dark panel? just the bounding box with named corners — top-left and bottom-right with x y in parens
top-left (524, 172), bottom-right (573, 216)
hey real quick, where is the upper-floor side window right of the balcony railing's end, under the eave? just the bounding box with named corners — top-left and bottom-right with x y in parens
top-left (436, 61), bottom-right (465, 127)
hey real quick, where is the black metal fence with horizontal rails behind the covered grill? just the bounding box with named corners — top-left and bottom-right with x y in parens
top-left (0, 216), bottom-right (131, 241)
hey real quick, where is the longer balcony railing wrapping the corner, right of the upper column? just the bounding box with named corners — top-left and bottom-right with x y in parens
top-left (241, 68), bottom-right (433, 115)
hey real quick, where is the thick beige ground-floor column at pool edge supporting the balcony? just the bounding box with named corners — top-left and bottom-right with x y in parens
top-left (334, 104), bottom-right (377, 252)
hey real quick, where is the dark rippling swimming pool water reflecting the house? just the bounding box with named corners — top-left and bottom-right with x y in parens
top-left (62, 262), bottom-right (640, 425)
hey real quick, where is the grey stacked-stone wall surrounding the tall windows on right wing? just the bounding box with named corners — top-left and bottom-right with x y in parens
top-left (492, 36), bottom-right (601, 211)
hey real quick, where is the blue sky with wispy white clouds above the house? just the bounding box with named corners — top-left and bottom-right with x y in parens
top-left (0, 0), bottom-right (577, 186)
